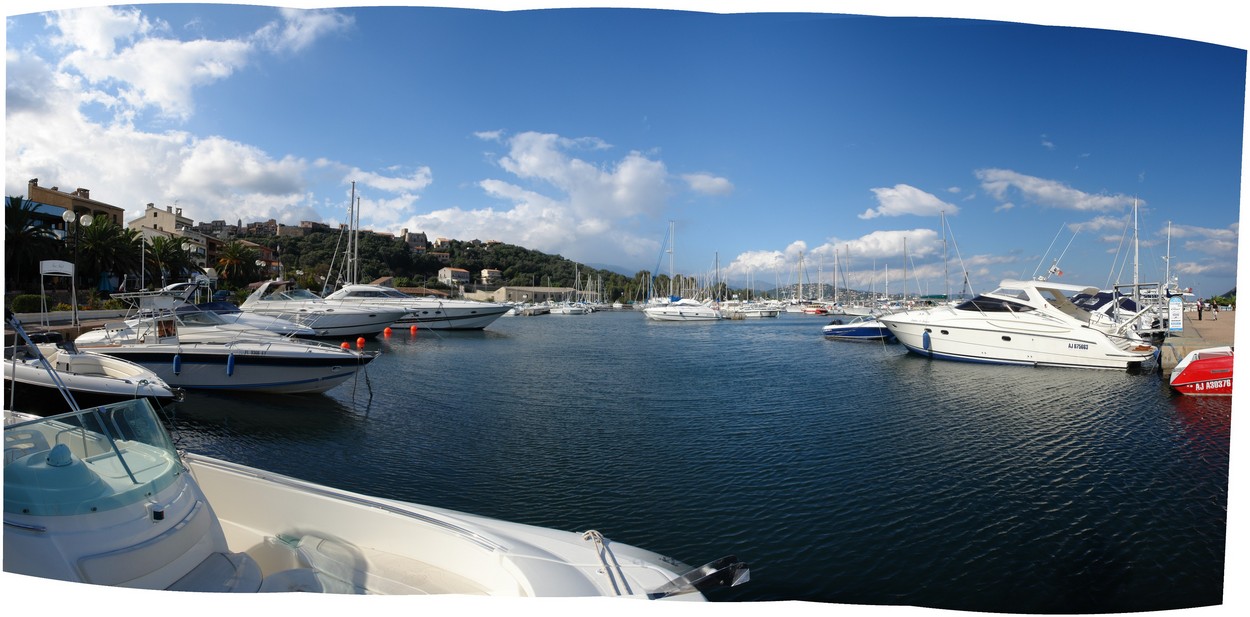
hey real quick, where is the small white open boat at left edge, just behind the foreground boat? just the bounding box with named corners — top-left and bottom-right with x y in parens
top-left (4, 335), bottom-right (183, 411)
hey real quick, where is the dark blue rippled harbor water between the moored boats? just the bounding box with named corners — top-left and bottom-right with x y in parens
top-left (151, 311), bottom-right (1231, 613)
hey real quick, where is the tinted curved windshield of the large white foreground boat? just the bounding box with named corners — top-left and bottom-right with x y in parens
top-left (4, 398), bottom-right (183, 516)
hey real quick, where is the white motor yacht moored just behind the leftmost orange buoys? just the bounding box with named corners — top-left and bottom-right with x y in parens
top-left (239, 281), bottom-right (409, 338)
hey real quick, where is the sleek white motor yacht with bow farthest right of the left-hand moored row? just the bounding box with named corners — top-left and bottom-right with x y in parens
top-left (325, 284), bottom-right (511, 330)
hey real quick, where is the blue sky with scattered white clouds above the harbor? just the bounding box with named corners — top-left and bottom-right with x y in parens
top-left (5, 1), bottom-right (1250, 295)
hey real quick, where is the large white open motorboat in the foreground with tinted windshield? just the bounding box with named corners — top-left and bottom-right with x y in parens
top-left (4, 400), bottom-right (750, 601)
